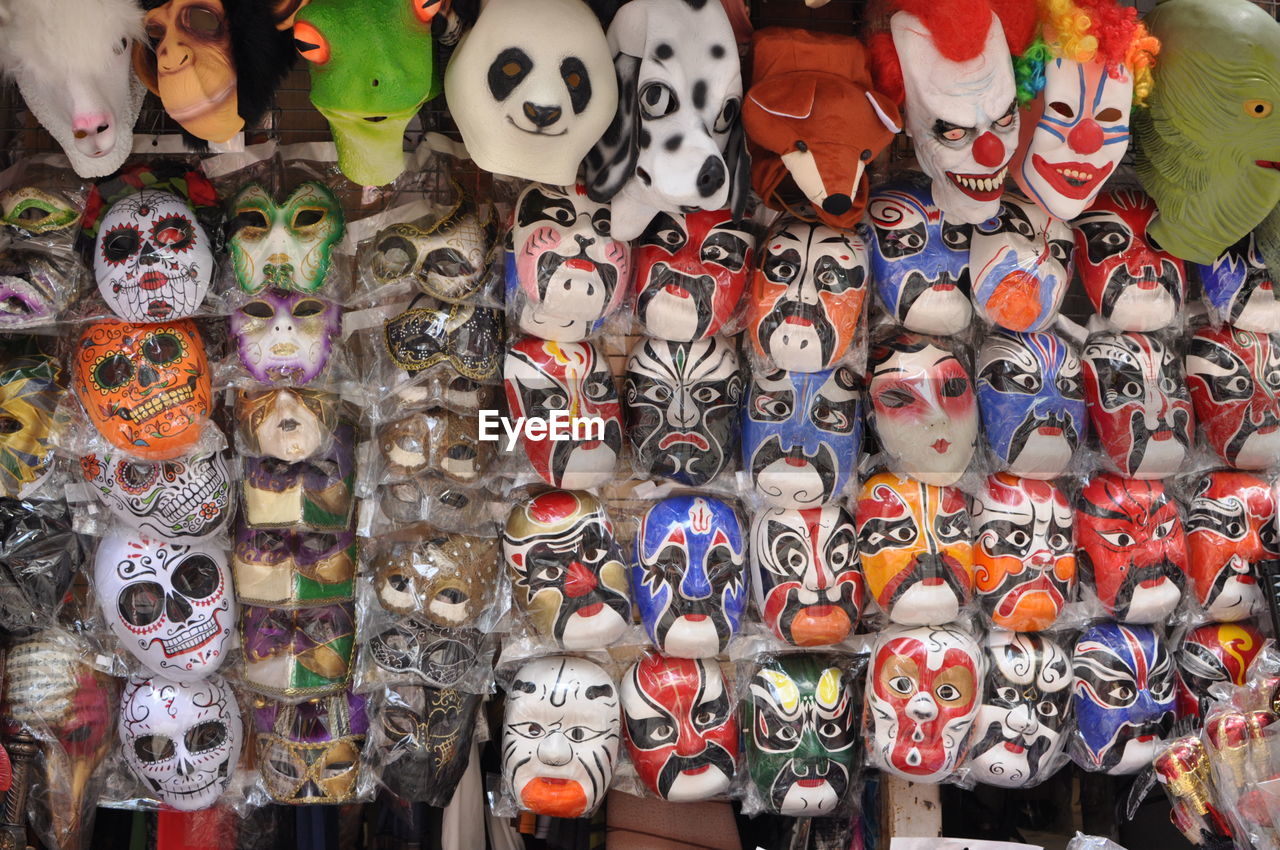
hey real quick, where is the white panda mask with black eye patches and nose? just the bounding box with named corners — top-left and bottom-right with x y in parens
top-left (444, 0), bottom-right (618, 186)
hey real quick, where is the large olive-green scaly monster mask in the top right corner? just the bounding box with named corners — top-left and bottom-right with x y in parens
top-left (1133, 0), bottom-right (1280, 265)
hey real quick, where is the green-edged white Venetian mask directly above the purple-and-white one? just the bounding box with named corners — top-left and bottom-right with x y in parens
top-left (227, 180), bottom-right (343, 294)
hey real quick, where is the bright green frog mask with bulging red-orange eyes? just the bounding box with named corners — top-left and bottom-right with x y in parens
top-left (293, 0), bottom-right (443, 186)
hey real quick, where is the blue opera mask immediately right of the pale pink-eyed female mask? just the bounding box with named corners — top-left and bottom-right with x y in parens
top-left (977, 332), bottom-right (1089, 480)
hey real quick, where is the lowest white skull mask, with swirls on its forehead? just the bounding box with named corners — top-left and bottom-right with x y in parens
top-left (119, 676), bottom-right (244, 812)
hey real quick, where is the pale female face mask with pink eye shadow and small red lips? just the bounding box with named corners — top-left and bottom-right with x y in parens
top-left (867, 333), bottom-right (978, 486)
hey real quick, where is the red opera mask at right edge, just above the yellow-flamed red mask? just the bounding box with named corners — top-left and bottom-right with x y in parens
top-left (1187, 470), bottom-right (1280, 622)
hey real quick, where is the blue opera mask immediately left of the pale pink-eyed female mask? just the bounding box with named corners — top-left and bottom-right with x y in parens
top-left (742, 366), bottom-right (863, 507)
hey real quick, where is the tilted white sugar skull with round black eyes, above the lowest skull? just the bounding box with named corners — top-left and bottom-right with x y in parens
top-left (93, 531), bottom-right (237, 682)
